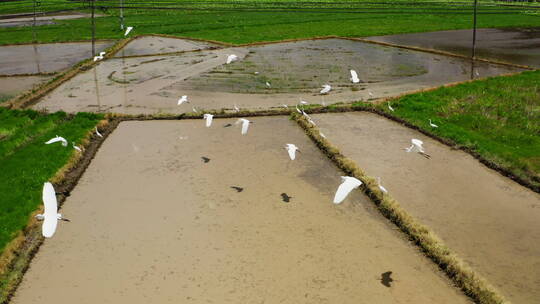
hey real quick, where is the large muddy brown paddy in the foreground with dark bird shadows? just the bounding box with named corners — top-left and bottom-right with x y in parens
top-left (12, 117), bottom-right (469, 304)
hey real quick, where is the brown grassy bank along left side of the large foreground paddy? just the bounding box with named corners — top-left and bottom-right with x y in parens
top-left (0, 119), bottom-right (120, 304)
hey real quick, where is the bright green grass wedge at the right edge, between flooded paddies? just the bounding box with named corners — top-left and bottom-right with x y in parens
top-left (376, 71), bottom-right (540, 191)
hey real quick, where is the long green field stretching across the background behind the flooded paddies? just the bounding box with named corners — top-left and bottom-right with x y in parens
top-left (0, 3), bottom-right (540, 45)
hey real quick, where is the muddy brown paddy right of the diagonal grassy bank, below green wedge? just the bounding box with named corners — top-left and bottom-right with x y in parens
top-left (313, 113), bottom-right (540, 304)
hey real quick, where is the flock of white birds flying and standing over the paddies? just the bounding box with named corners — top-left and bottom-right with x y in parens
top-left (36, 27), bottom-right (438, 238)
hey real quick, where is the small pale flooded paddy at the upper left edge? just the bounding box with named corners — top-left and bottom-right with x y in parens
top-left (0, 41), bottom-right (114, 75)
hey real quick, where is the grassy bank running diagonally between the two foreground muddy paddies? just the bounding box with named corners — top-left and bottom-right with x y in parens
top-left (292, 113), bottom-right (510, 304)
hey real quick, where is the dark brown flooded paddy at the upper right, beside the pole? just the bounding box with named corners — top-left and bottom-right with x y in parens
top-left (367, 28), bottom-right (540, 68)
